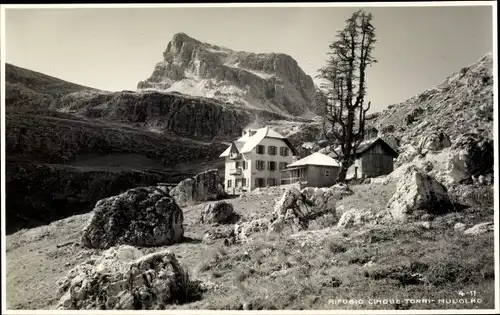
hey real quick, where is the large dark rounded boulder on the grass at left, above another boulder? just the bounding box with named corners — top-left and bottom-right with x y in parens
top-left (82, 187), bottom-right (184, 248)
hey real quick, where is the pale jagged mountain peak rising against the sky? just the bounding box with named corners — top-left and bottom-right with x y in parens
top-left (137, 33), bottom-right (315, 116)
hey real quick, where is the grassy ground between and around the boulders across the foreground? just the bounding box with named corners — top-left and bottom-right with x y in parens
top-left (6, 184), bottom-right (494, 309)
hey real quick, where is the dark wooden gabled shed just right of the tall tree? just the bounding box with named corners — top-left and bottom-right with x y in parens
top-left (330, 138), bottom-right (399, 178)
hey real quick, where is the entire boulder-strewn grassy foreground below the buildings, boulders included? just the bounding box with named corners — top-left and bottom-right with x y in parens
top-left (7, 148), bottom-right (494, 310)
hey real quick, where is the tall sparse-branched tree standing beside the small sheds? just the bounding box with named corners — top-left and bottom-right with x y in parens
top-left (317, 10), bottom-right (377, 182)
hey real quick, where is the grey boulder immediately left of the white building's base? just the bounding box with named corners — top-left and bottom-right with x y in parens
top-left (170, 169), bottom-right (226, 207)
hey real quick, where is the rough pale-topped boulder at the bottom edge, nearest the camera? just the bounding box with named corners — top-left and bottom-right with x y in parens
top-left (57, 245), bottom-right (198, 310)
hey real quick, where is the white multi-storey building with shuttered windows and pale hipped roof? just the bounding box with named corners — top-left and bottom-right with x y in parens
top-left (220, 127), bottom-right (297, 194)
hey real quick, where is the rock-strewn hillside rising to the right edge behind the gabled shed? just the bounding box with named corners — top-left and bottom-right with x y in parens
top-left (367, 53), bottom-right (494, 165)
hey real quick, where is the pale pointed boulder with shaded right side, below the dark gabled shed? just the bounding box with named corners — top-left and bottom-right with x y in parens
top-left (387, 166), bottom-right (450, 221)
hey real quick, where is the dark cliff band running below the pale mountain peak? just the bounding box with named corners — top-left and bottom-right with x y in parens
top-left (52, 91), bottom-right (303, 141)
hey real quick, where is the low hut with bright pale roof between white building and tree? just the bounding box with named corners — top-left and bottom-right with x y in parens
top-left (281, 152), bottom-right (340, 188)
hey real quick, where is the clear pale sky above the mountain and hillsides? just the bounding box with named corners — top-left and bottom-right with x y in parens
top-left (1, 6), bottom-right (493, 112)
